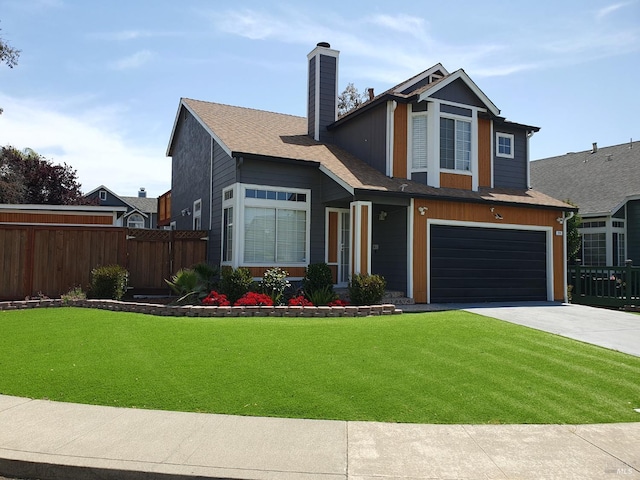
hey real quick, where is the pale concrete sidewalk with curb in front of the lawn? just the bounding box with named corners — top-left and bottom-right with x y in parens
top-left (0, 396), bottom-right (640, 480)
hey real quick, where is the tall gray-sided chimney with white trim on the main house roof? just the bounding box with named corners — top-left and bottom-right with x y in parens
top-left (307, 42), bottom-right (340, 142)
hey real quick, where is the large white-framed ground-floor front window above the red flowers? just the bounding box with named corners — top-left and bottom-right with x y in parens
top-left (222, 184), bottom-right (311, 266)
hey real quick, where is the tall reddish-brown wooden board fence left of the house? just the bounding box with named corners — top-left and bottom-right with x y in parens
top-left (0, 225), bottom-right (207, 300)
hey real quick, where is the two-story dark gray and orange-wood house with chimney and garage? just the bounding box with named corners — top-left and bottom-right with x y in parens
top-left (167, 43), bottom-right (575, 303)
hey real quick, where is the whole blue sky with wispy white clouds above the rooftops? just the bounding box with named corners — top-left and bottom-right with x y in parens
top-left (0, 0), bottom-right (640, 196)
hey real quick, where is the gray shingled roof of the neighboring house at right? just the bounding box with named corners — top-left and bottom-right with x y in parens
top-left (531, 142), bottom-right (640, 215)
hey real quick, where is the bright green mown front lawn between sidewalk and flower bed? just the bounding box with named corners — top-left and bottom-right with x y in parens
top-left (0, 308), bottom-right (640, 424)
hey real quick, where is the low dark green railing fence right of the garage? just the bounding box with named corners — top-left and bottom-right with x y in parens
top-left (568, 262), bottom-right (640, 307)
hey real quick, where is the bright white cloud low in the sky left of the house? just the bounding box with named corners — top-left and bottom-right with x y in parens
top-left (0, 95), bottom-right (171, 197)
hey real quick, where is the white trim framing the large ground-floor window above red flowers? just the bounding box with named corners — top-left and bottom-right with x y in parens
top-left (220, 183), bottom-right (311, 268)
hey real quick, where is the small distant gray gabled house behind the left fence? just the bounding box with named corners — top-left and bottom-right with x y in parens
top-left (85, 185), bottom-right (158, 228)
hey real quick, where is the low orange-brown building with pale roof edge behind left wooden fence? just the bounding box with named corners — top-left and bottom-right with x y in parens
top-left (0, 204), bottom-right (126, 226)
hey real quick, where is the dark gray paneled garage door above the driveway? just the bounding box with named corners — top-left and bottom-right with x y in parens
top-left (430, 225), bottom-right (547, 303)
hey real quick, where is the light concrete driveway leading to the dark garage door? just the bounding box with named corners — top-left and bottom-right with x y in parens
top-left (458, 302), bottom-right (640, 357)
